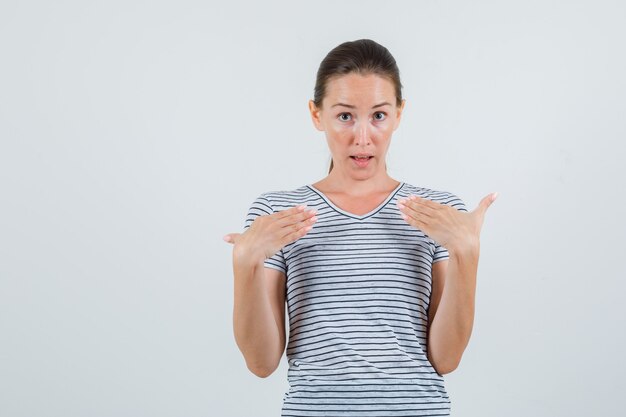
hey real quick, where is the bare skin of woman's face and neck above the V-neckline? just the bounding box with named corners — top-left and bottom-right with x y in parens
top-left (309, 73), bottom-right (406, 202)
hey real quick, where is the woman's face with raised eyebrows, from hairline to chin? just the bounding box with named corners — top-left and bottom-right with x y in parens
top-left (309, 73), bottom-right (405, 179)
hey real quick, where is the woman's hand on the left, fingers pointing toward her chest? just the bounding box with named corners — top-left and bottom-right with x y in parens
top-left (224, 205), bottom-right (317, 261)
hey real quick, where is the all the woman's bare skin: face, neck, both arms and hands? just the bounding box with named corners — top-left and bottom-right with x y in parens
top-left (224, 73), bottom-right (497, 377)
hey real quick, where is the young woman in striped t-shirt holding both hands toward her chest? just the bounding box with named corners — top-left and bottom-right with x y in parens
top-left (224, 39), bottom-right (496, 416)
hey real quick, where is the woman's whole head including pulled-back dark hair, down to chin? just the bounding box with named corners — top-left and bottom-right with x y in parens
top-left (309, 39), bottom-right (405, 179)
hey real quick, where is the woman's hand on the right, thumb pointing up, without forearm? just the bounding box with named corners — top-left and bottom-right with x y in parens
top-left (398, 193), bottom-right (498, 252)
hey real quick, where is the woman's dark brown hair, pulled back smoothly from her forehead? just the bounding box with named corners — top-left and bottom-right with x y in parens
top-left (313, 39), bottom-right (402, 173)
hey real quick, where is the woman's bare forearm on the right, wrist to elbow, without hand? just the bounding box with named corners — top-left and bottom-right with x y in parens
top-left (428, 240), bottom-right (480, 375)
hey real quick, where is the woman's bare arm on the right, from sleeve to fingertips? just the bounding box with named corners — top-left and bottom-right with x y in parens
top-left (398, 193), bottom-right (498, 375)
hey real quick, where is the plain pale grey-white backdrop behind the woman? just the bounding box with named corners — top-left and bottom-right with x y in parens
top-left (0, 0), bottom-right (626, 417)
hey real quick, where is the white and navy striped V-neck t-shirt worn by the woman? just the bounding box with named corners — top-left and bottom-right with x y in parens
top-left (244, 182), bottom-right (467, 417)
